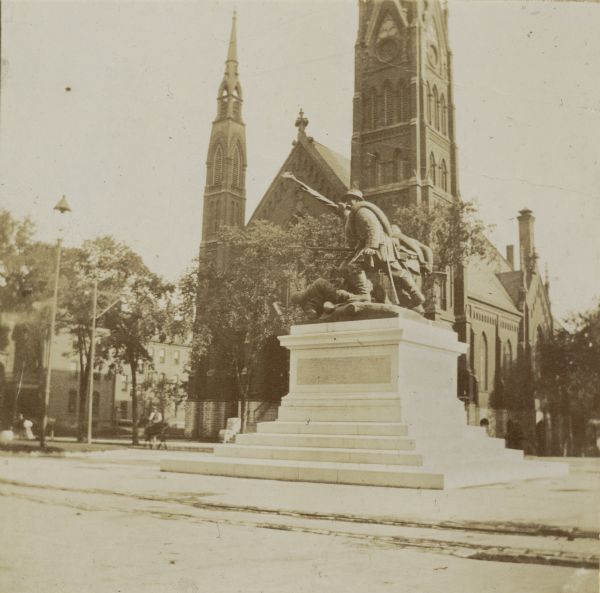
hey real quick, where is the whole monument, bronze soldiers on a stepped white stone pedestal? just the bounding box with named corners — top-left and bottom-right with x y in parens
top-left (161, 187), bottom-right (568, 489)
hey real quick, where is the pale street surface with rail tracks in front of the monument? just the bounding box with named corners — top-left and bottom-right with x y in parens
top-left (0, 449), bottom-right (600, 593)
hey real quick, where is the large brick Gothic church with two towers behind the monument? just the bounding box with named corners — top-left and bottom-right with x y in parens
top-left (189, 0), bottom-right (553, 452)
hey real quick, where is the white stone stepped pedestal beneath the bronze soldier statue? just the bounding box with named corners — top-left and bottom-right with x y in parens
top-left (161, 311), bottom-right (568, 489)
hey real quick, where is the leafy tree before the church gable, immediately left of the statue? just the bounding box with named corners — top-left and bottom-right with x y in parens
top-left (180, 215), bottom-right (344, 426)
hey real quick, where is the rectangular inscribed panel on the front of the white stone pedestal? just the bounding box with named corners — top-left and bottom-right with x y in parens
top-left (296, 356), bottom-right (392, 385)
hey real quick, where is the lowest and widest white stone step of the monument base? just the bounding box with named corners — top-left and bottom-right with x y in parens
top-left (161, 455), bottom-right (568, 490)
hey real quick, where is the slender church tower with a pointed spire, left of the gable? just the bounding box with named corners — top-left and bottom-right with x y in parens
top-left (202, 13), bottom-right (247, 246)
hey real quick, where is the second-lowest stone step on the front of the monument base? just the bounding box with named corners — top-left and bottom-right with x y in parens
top-left (214, 444), bottom-right (423, 466)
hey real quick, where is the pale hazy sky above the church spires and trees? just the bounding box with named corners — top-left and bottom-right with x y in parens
top-left (0, 0), bottom-right (600, 318)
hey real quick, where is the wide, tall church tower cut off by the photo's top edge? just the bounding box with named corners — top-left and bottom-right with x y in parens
top-left (351, 0), bottom-right (458, 211)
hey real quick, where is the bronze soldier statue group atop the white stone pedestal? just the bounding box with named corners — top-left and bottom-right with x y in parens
top-left (283, 173), bottom-right (433, 320)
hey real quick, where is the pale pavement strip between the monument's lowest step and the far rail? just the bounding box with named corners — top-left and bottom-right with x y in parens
top-left (0, 443), bottom-right (600, 539)
